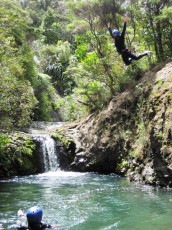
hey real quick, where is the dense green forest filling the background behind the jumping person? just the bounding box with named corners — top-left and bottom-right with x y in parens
top-left (0, 0), bottom-right (172, 126)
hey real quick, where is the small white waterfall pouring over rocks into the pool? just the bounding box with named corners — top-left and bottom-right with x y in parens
top-left (31, 133), bottom-right (59, 172)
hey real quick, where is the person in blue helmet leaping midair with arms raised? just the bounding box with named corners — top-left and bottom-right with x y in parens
top-left (108, 17), bottom-right (152, 66)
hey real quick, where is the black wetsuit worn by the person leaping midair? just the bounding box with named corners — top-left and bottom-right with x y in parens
top-left (108, 22), bottom-right (147, 65)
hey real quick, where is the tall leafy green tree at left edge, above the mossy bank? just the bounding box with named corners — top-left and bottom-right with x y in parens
top-left (0, 1), bottom-right (37, 128)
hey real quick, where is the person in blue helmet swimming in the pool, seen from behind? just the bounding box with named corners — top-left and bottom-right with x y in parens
top-left (17, 206), bottom-right (52, 230)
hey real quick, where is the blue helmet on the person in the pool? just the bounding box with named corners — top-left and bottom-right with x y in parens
top-left (26, 206), bottom-right (43, 223)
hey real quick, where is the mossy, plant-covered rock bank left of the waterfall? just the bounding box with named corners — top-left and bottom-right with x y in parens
top-left (0, 133), bottom-right (36, 178)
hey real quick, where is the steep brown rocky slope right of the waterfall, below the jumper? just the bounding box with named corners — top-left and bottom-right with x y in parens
top-left (57, 62), bottom-right (172, 187)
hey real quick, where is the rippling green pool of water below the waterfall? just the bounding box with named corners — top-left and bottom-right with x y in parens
top-left (0, 171), bottom-right (172, 230)
